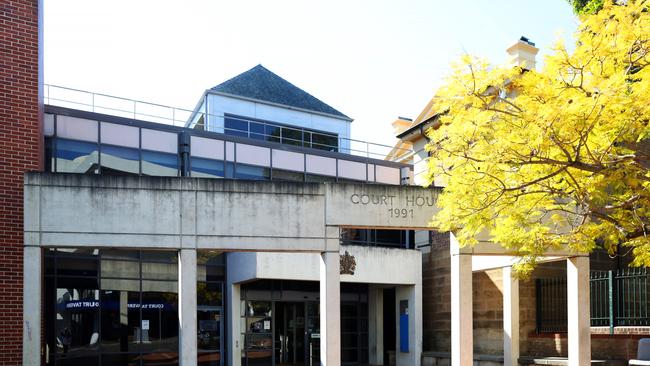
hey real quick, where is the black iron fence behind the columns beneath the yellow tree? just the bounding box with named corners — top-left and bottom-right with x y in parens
top-left (535, 268), bottom-right (650, 334)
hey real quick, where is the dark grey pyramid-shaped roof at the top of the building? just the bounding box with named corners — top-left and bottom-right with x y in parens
top-left (210, 65), bottom-right (350, 119)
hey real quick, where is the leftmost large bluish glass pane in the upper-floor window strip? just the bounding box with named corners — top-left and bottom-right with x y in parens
top-left (56, 139), bottom-right (98, 174)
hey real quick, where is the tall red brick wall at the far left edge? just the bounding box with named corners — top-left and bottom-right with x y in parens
top-left (0, 0), bottom-right (43, 365)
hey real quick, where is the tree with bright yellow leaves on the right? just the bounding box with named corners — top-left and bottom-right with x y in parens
top-left (428, 0), bottom-right (650, 275)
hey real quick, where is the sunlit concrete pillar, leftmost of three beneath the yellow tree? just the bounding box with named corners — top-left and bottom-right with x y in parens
top-left (450, 234), bottom-right (474, 366)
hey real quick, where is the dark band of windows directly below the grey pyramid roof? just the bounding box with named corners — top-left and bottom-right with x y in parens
top-left (224, 115), bottom-right (339, 151)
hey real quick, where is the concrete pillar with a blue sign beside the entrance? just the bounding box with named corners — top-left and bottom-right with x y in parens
top-left (395, 286), bottom-right (422, 366)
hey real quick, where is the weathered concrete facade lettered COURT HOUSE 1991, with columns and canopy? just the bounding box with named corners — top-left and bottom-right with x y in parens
top-left (24, 173), bottom-right (438, 365)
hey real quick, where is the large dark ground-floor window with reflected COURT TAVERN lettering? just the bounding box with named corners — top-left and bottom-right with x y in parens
top-left (44, 249), bottom-right (178, 365)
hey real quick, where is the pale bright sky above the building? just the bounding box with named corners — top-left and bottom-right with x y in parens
top-left (44, 0), bottom-right (578, 145)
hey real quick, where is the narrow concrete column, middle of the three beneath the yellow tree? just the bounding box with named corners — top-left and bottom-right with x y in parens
top-left (503, 267), bottom-right (519, 366)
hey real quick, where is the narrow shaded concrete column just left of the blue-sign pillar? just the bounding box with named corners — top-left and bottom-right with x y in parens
top-left (368, 285), bottom-right (384, 365)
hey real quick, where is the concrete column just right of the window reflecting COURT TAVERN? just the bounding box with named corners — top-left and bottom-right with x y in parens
top-left (178, 249), bottom-right (197, 366)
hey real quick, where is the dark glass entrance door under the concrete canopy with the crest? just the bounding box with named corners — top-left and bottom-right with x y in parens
top-left (274, 302), bottom-right (307, 365)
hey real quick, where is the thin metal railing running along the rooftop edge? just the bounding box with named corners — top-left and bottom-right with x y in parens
top-left (44, 84), bottom-right (413, 159)
